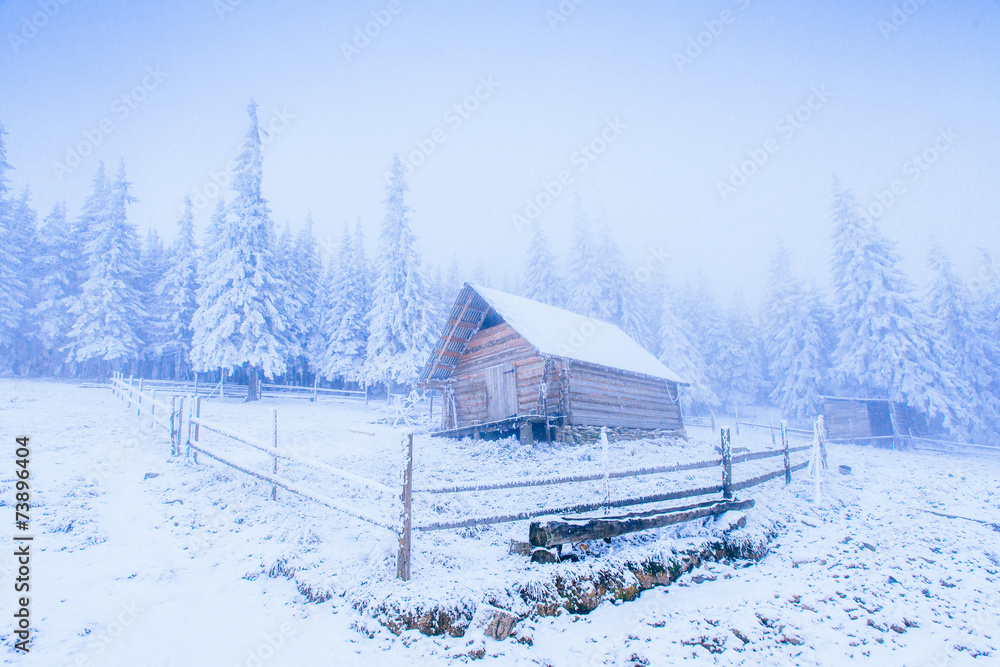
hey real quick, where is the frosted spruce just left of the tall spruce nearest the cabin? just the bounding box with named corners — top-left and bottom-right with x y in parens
top-left (320, 225), bottom-right (369, 384)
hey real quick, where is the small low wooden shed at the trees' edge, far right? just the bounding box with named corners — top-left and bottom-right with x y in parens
top-left (821, 396), bottom-right (913, 447)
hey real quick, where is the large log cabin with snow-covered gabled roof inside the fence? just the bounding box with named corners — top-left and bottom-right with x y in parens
top-left (420, 283), bottom-right (687, 442)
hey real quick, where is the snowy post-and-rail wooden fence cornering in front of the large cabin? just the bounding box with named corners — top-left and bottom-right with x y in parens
top-left (111, 374), bottom-right (826, 580)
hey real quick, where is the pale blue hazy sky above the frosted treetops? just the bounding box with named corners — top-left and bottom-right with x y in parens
top-left (0, 0), bottom-right (1000, 301)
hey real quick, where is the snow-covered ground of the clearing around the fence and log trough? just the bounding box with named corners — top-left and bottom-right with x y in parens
top-left (0, 380), bottom-right (1000, 666)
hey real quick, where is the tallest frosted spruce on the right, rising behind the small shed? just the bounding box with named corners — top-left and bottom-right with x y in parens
top-left (833, 190), bottom-right (968, 430)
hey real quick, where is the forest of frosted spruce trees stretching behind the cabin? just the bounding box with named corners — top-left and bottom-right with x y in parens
top-left (0, 103), bottom-right (1000, 440)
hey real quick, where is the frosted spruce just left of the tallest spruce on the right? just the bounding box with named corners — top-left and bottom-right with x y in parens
top-left (761, 245), bottom-right (829, 419)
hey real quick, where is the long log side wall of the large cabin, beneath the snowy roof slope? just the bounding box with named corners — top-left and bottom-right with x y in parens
top-left (567, 362), bottom-right (684, 430)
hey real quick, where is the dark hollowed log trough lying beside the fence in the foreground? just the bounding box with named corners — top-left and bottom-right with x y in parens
top-left (528, 500), bottom-right (754, 548)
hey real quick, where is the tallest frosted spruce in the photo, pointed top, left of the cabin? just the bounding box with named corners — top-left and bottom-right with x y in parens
top-left (191, 101), bottom-right (298, 401)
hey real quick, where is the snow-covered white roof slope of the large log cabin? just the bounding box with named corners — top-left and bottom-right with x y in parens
top-left (469, 285), bottom-right (687, 384)
